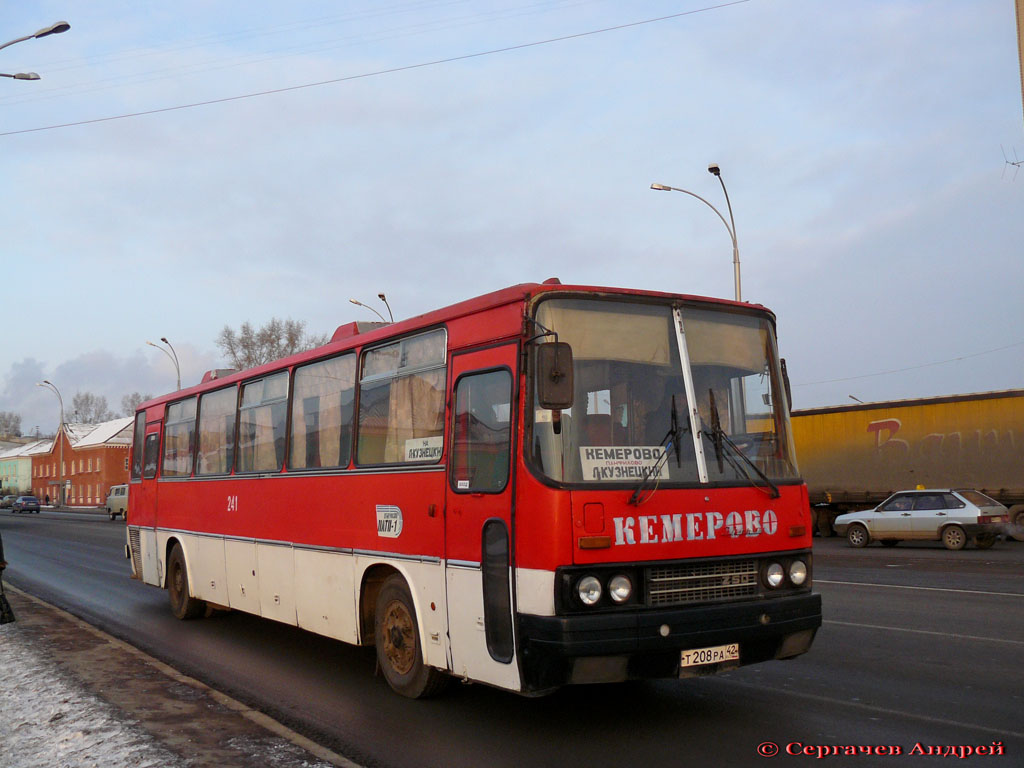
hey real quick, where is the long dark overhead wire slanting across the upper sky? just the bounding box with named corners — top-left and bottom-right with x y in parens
top-left (0, 0), bottom-right (751, 136)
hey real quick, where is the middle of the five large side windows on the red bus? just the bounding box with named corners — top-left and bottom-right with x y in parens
top-left (239, 371), bottom-right (288, 472)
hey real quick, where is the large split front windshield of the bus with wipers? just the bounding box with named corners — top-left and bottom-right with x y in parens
top-left (530, 298), bottom-right (798, 486)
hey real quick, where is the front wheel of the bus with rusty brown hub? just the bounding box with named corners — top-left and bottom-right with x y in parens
top-left (374, 573), bottom-right (449, 698)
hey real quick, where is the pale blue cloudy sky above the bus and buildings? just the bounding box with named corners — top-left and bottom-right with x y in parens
top-left (0, 0), bottom-right (1024, 432)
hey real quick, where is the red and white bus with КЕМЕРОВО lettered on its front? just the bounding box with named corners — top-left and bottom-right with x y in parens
top-left (126, 280), bottom-right (821, 697)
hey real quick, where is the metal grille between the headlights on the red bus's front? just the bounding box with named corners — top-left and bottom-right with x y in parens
top-left (647, 560), bottom-right (758, 606)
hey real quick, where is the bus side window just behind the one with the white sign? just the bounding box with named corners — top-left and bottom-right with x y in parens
top-left (288, 354), bottom-right (355, 469)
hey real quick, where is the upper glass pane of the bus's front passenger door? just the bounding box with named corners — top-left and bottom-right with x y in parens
top-left (452, 371), bottom-right (512, 493)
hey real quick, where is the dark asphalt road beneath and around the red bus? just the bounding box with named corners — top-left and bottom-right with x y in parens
top-left (0, 512), bottom-right (1024, 768)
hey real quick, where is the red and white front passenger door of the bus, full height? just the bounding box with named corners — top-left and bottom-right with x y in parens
top-left (444, 343), bottom-right (520, 689)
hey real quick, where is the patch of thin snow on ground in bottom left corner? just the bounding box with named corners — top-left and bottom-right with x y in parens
top-left (0, 623), bottom-right (186, 768)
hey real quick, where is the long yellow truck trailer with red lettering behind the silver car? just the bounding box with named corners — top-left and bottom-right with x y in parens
top-left (793, 389), bottom-right (1024, 541)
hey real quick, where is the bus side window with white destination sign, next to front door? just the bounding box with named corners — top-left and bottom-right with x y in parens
top-left (356, 329), bottom-right (446, 464)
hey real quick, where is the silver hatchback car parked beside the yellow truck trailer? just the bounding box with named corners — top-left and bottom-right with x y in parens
top-left (835, 488), bottom-right (1010, 550)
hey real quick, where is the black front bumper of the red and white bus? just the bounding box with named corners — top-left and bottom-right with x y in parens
top-left (519, 594), bottom-right (821, 692)
